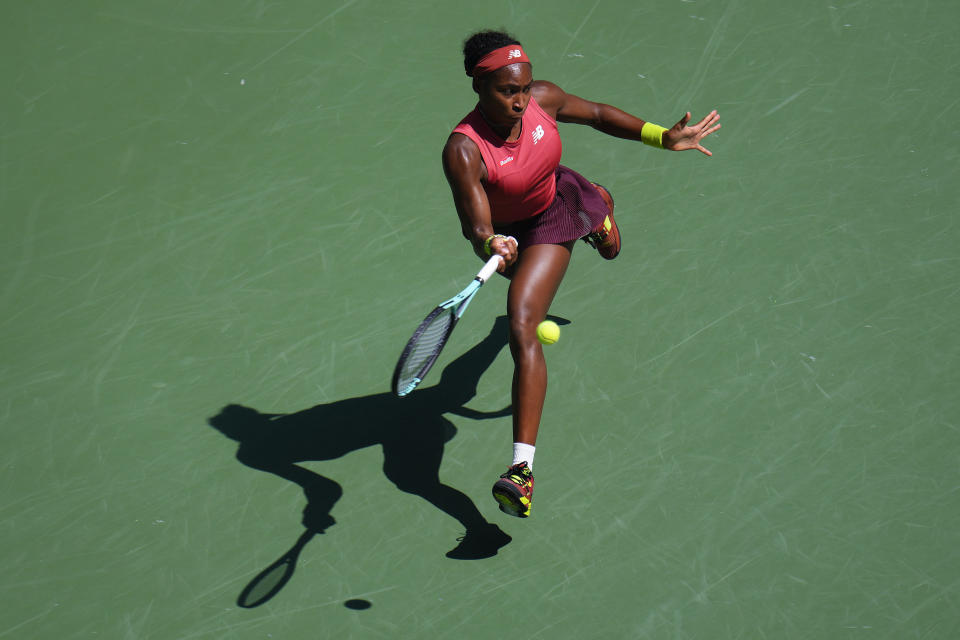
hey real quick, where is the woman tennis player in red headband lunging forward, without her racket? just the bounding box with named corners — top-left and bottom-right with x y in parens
top-left (443, 31), bottom-right (720, 518)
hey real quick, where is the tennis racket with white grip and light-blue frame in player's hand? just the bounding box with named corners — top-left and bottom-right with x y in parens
top-left (392, 256), bottom-right (503, 397)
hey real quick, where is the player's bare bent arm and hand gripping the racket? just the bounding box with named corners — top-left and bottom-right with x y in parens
top-left (443, 133), bottom-right (517, 271)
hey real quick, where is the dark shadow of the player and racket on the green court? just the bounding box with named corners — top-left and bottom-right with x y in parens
top-left (208, 317), bottom-right (511, 607)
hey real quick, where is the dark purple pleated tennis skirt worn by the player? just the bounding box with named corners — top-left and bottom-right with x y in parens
top-left (493, 165), bottom-right (612, 251)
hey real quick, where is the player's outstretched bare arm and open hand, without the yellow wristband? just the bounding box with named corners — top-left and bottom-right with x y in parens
top-left (533, 80), bottom-right (720, 156)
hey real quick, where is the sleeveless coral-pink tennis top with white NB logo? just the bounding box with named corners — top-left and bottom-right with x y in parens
top-left (453, 98), bottom-right (563, 224)
